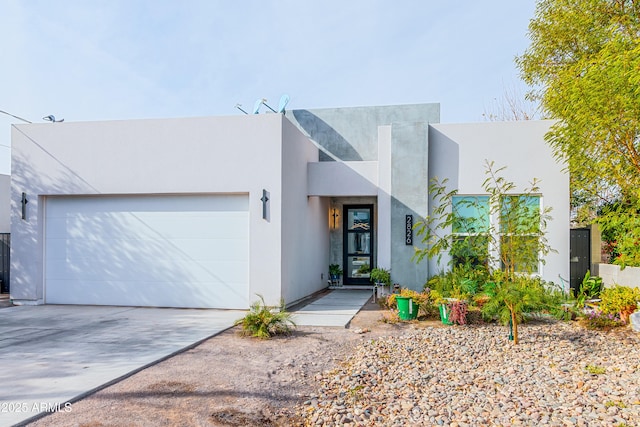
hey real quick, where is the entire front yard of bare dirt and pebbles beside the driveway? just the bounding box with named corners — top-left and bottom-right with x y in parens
top-left (26, 304), bottom-right (640, 427)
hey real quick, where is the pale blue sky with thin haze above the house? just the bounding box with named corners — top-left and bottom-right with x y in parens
top-left (0, 0), bottom-right (535, 174)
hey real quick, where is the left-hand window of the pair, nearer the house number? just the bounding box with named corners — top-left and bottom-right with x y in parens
top-left (451, 196), bottom-right (490, 266)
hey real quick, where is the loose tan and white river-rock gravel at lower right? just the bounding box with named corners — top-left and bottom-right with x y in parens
top-left (298, 321), bottom-right (640, 427)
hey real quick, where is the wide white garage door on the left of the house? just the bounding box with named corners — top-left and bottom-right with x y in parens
top-left (45, 195), bottom-right (249, 309)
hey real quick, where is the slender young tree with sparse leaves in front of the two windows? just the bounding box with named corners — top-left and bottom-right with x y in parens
top-left (414, 161), bottom-right (557, 344)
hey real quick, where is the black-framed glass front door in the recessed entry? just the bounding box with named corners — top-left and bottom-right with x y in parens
top-left (343, 205), bottom-right (373, 285)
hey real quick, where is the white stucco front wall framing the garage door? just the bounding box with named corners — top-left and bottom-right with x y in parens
top-left (11, 114), bottom-right (300, 304)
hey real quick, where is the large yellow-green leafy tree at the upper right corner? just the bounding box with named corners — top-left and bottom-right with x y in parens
top-left (516, 0), bottom-right (640, 200)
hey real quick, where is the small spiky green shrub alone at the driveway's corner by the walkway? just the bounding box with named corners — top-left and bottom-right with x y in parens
top-left (235, 295), bottom-right (296, 339)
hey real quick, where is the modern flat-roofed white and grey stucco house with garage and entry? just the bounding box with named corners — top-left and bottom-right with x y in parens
top-left (10, 104), bottom-right (569, 309)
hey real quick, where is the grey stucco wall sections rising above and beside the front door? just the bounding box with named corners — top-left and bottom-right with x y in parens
top-left (287, 104), bottom-right (440, 289)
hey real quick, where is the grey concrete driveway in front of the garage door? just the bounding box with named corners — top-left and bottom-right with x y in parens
top-left (0, 305), bottom-right (244, 426)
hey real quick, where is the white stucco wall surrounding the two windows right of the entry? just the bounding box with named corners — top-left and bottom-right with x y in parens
top-left (429, 121), bottom-right (570, 284)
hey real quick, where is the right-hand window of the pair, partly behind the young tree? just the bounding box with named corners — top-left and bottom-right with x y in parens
top-left (500, 195), bottom-right (541, 273)
